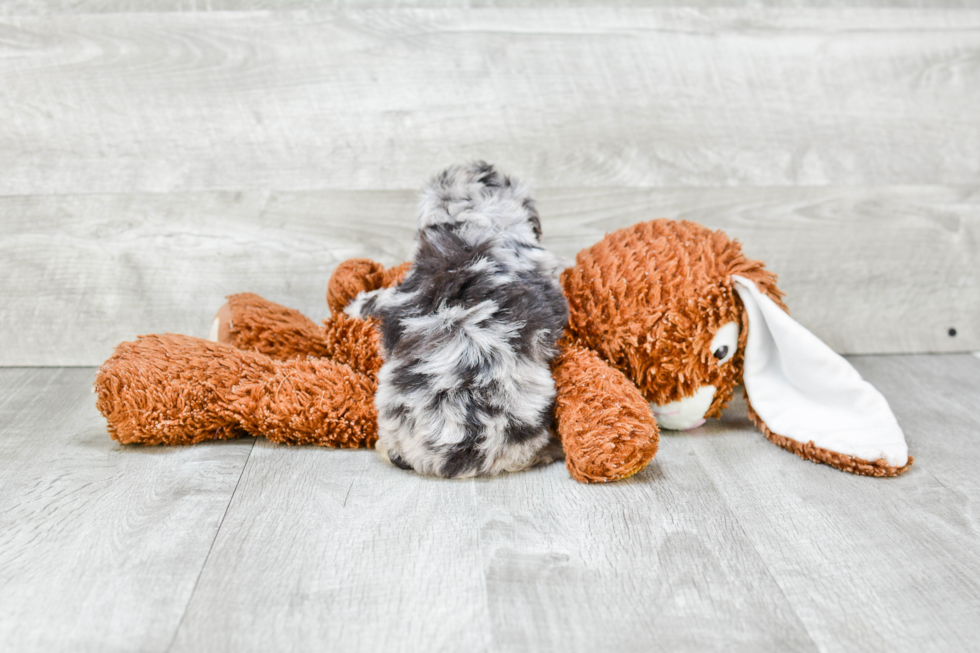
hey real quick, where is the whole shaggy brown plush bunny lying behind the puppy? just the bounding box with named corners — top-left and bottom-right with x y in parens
top-left (96, 220), bottom-right (912, 482)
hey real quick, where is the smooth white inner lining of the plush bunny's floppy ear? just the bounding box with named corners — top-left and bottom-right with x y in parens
top-left (732, 275), bottom-right (908, 467)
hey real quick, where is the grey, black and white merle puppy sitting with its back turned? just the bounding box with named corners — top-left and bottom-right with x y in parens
top-left (346, 161), bottom-right (568, 477)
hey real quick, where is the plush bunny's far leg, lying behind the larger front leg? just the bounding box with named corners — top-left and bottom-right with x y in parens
top-left (210, 293), bottom-right (382, 378)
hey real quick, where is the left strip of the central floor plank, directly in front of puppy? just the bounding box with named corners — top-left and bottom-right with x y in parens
top-left (172, 441), bottom-right (498, 652)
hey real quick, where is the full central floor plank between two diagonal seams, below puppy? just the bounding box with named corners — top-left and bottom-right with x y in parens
top-left (173, 440), bottom-right (816, 652)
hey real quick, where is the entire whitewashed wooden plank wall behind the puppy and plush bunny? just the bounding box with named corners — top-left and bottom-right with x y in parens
top-left (0, 0), bottom-right (980, 365)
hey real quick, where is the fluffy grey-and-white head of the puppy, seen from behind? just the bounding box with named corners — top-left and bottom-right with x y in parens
top-left (418, 161), bottom-right (541, 244)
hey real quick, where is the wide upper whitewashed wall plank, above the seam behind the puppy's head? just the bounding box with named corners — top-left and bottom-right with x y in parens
top-left (0, 6), bottom-right (980, 195)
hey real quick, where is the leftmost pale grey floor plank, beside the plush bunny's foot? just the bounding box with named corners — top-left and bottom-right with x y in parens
top-left (0, 369), bottom-right (252, 651)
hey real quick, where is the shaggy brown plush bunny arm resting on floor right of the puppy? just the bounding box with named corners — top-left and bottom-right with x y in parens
top-left (552, 345), bottom-right (660, 483)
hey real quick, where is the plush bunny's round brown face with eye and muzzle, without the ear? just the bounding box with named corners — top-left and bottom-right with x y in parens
top-left (562, 220), bottom-right (785, 429)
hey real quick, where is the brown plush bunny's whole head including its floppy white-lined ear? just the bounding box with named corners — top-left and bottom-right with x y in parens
top-left (562, 220), bottom-right (909, 475)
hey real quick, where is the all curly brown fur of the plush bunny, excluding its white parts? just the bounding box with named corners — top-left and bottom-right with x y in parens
top-left (96, 220), bottom-right (912, 482)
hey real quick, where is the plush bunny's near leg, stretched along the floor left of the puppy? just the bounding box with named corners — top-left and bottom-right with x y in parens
top-left (95, 334), bottom-right (377, 447)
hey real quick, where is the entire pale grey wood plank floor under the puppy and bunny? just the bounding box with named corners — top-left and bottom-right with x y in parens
top-left (0, 355), bottom-right (980, 651)
